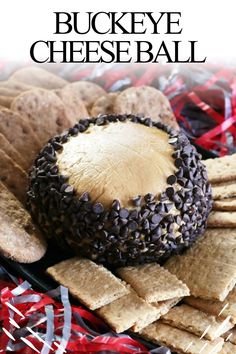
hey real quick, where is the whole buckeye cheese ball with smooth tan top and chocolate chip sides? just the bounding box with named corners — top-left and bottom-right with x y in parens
top-left (28, 115), bottom-right (212, 266)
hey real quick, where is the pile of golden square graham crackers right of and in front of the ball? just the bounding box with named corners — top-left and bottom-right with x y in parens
top-left (47, 154), bottom-right (236, 354)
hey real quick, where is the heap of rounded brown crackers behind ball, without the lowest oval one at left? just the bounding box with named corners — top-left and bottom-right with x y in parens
top-left (0, 67), bottom-right (178, 203)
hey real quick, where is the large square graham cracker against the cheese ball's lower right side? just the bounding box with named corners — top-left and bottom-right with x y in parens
top-left (165, 255), bottom-right (236, 301)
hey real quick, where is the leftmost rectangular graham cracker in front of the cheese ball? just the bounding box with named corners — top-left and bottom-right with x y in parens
top-left (47, 257), bottom-right (129, 310)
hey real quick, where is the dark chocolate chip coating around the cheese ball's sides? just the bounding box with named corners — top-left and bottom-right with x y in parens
top-left (28, 115), bottom-right (212, 267)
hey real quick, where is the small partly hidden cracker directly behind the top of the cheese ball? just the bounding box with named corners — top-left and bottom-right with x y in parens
top-left (90, 92), bottom-right (119, 117)
